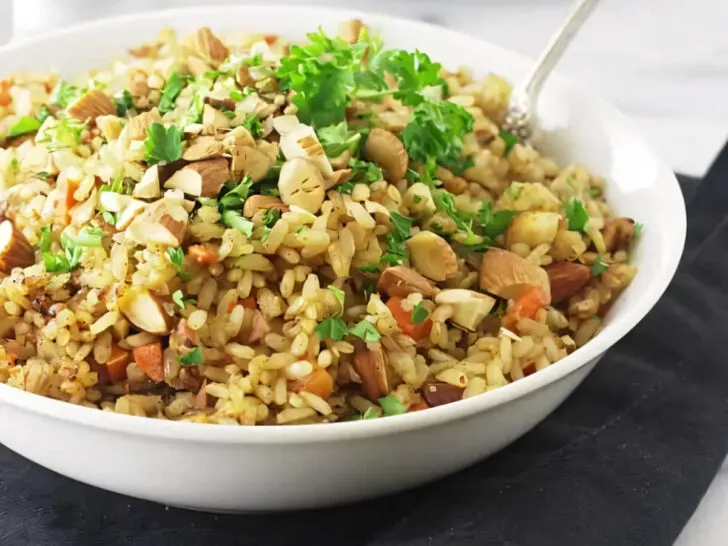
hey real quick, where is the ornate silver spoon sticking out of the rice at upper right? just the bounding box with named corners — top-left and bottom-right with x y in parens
top-left (503, 0), bottom-right (599, 142)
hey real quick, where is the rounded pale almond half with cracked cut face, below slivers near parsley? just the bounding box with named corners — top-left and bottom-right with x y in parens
top-left (278, 158), bottom-right (325, 214)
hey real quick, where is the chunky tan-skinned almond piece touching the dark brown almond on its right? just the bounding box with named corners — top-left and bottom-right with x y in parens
top-left (480, 247), bottom-right (551, 305)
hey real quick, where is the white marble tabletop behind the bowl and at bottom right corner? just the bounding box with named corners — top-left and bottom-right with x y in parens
top-left (0, 0), bottom-right (728, 536)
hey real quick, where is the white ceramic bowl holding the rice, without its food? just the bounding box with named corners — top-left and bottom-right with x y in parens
top-left (0, 6), bottom-right (685, 511)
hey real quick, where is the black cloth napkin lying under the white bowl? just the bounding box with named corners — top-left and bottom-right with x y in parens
top-left (0, 146), bottom-right (728, 546)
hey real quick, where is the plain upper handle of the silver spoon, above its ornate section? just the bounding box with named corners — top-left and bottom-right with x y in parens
top-left (522, 0), bottom-right (599, 101)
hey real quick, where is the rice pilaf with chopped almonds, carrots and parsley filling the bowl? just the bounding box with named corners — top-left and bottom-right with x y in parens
top-left (0, 21), bottom-right (640, 425)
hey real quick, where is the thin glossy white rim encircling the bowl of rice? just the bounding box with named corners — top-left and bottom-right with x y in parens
top-left (0, 4), bottom-right (686, 444)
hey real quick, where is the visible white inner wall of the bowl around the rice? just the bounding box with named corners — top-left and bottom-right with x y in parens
top-left (0, 6), bottom-right (685, 440)
